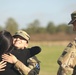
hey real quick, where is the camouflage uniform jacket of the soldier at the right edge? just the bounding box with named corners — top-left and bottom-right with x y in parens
top-left (57, 40), bottom-right (76, 75)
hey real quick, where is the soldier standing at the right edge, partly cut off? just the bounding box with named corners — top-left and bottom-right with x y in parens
top-left (57, 11), bottom-right (76, 75)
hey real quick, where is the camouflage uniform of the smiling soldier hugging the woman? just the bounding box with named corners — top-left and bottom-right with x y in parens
top-left (15, 56), bottom-right (40, 75)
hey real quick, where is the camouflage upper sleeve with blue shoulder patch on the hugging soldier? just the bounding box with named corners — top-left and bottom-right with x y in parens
top-left (27, 56), bottom-right (40, 75)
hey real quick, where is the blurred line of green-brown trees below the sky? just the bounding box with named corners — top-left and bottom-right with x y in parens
top-left (0, 18), bottom-right (74, 34)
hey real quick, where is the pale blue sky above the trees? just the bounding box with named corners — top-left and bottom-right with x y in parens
top-left (0, 0), bottom-right (76, 28)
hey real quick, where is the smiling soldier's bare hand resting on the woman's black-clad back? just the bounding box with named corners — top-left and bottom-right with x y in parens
top-left (2, 53), bottom-right (17, 64)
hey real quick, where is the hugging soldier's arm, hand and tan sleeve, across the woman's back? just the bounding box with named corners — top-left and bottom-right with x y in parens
top-left (2, 54), bottom-right (39, 75)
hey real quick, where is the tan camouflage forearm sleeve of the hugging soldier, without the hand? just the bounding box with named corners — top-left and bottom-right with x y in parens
top-left (14, 60), bottom-right (38, 75)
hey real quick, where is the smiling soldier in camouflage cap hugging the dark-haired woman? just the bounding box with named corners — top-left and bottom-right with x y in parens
top-left (2, 30), bottom-right (41, 75)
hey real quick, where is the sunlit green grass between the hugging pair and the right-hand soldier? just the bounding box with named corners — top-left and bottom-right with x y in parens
top-left (31, 43), bottom-right (65, 75)
